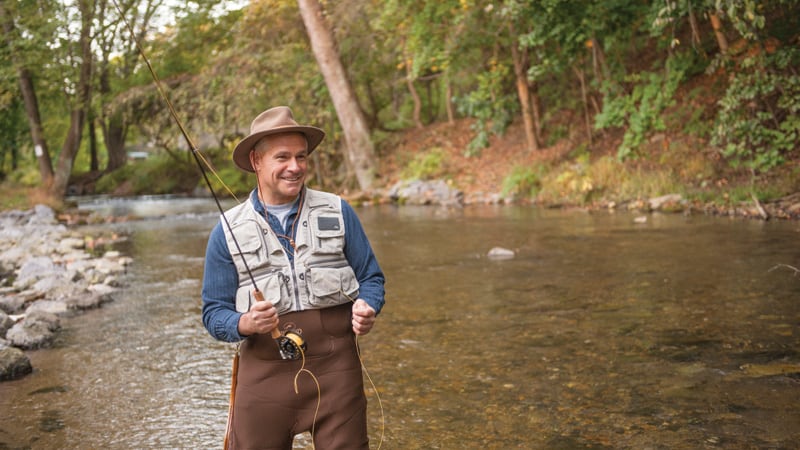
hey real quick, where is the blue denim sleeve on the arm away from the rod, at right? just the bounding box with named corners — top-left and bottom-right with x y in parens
top-left (342, 199), bottom-right (386, 313)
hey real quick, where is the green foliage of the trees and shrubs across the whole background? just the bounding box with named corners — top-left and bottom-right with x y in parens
top-left (6, 0), bottom-right (800, 201)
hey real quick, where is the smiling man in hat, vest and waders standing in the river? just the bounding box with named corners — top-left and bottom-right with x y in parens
top-left (202, 106), bottom-right (384, 450)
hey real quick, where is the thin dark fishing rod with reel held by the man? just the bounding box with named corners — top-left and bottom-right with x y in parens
top-left (112, 0), bottom-right (306, 360)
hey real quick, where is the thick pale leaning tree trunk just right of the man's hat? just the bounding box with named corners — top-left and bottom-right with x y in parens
top-left (297, 0), bottom-right (377, 192)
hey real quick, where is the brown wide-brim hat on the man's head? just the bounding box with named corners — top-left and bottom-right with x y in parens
top-left (233, 106), bottom-right (325, 172)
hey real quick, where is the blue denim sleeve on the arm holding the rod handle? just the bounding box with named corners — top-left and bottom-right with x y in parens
top-left (202, 222), bottom-right (244, 342)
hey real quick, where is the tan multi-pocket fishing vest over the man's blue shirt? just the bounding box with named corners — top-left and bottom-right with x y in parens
top-left (217, 188), bottom-right (359, 314)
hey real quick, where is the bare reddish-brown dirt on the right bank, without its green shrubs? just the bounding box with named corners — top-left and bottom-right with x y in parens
top-left (379, 118), bottom-right (800, 219)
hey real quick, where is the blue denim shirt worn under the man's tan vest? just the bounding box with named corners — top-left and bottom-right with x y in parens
top-left (202, 190), bottom-right (385, 342)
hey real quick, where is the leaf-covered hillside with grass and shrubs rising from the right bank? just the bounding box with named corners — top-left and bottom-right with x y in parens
top-left (379, 112), bottom-right (800, 218)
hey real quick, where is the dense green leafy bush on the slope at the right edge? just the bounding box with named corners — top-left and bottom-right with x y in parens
top-left (712, 47), bottom-right (800, 172)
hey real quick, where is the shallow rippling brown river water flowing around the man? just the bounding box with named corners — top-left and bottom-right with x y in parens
top-left (0, 199), bottom-right (800, 449)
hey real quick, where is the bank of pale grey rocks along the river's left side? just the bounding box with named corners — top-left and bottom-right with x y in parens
top-left (0, 205), bottom-right (132, 381)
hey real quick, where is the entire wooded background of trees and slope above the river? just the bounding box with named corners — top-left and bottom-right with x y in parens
top-left (0, 0), bottom-right (800, 215)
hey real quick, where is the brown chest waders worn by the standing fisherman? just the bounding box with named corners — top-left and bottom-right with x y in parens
top-left (226, 303), bottom-right (369, 450)
